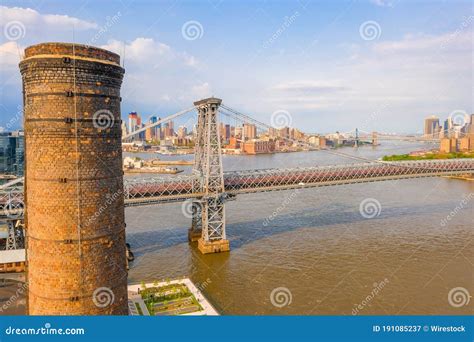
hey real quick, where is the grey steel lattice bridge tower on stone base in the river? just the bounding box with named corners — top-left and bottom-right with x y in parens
top-left (189, 97), bottom-right (230, 254)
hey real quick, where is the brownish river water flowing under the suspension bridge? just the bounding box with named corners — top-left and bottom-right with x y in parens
top-left (1, 142), bottom-right (474, 315)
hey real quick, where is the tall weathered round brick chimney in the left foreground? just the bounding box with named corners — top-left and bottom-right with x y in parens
top-left (20, 43), bottom-right (128, 315)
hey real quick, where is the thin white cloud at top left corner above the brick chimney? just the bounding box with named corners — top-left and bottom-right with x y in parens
top-left (0, 6), bottom-right (98, 30)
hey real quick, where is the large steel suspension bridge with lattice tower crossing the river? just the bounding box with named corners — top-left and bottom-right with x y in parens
top-left (0, 97), bottom-right (474, 253)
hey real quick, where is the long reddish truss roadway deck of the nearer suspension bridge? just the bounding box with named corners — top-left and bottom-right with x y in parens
top-left (0, 158), bottom-right (474, 218)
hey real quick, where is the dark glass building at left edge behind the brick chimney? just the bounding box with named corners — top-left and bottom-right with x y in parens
top-left (0, 131), bottom-right (25, 177)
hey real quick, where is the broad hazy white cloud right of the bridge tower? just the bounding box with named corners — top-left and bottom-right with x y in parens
top-left (239, 26), bottom-right (474, 131)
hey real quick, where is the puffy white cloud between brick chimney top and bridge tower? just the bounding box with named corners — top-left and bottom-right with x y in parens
top-left (101, 37), bottom-right (206, 109)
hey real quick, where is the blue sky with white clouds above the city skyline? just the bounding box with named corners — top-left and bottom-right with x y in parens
top-left (0, 0), bottom-right (474, 132)
